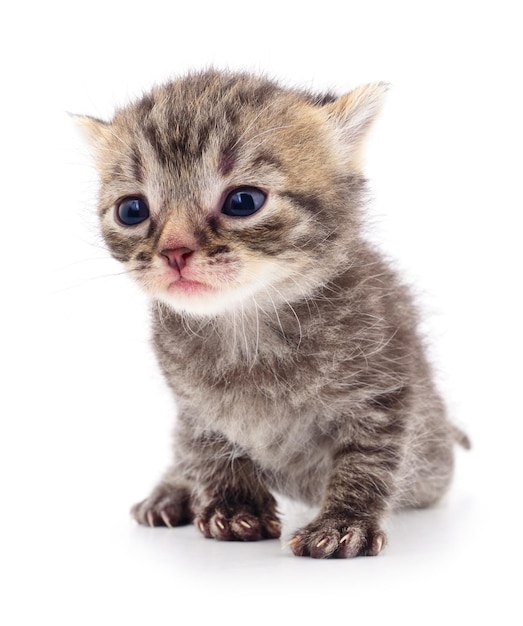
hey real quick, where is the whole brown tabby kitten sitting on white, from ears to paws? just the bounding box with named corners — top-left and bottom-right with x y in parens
top-left (74, 70), bottom-right (468, 558)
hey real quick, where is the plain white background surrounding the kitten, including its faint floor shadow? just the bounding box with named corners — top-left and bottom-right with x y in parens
top-left (0, 0), bottom-right (523, 626)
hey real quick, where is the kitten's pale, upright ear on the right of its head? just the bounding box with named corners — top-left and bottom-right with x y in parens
top-left (325, 83), bottom-right (388, 156)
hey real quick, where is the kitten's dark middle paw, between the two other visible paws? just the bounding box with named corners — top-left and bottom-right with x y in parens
top-left (194, 503), bottom-right (281, 541)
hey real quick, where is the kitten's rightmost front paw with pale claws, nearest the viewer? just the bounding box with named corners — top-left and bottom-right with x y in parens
top-left (288, 519), bottom-right (386, 559)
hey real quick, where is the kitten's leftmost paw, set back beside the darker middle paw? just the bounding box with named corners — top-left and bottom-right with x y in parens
top-left (131, 486), bottom-right (193, 528)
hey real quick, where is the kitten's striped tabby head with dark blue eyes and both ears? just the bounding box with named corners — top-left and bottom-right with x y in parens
top-left (77, 71), bottom-right (385, 315)
